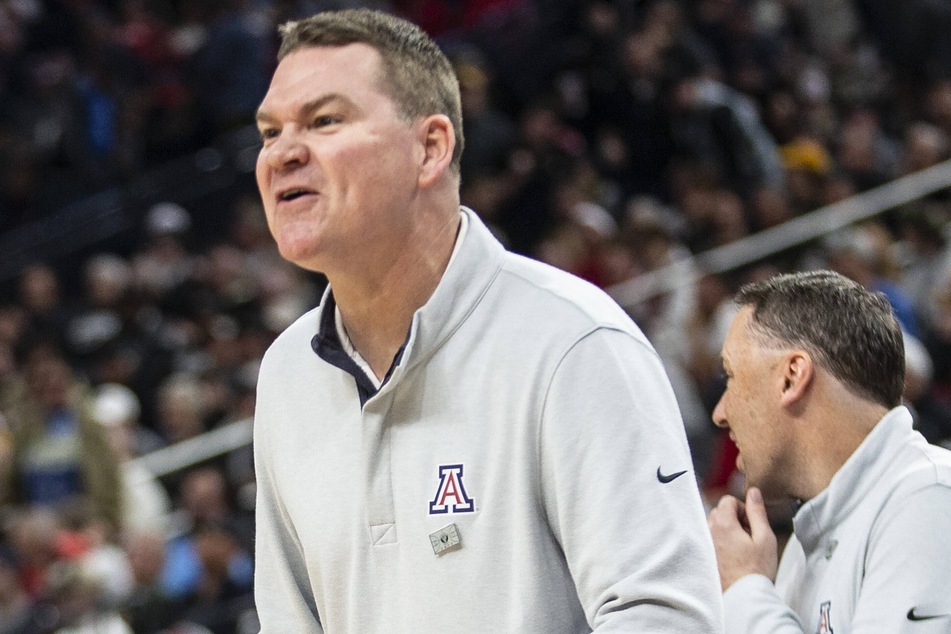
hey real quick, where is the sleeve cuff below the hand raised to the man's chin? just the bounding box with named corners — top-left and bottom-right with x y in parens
top-left (723, 574), bottom-right (803, 634)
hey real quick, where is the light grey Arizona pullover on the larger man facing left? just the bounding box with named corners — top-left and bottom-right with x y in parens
top-left (254, 209), bottom-right (723, 634)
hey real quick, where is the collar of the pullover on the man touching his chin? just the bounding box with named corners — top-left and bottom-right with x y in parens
top-left (793, 406), bottom-right (914, 556)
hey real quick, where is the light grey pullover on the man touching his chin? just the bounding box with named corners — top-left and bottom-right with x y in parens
top-left (723, 407), bottom-right (951, 634)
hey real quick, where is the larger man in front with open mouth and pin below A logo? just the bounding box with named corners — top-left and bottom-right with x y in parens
top-left (254, 10), bottom-right (722, 634)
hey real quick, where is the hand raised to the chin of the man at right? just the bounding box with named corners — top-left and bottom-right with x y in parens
top-left (707, 487), bottom-right (778, 591)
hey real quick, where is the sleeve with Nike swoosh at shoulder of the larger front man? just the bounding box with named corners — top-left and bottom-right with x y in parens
top-left (539, 328), bottom-right (723, 634)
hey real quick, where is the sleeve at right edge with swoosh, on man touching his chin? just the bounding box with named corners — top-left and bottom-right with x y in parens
top-left (852, 484), bottom-right (951, 634)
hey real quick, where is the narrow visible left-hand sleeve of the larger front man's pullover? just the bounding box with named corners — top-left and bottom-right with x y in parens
top-left (254, 398), bottom-right (323, 634)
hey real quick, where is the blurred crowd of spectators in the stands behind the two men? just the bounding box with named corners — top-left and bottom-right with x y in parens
top-left (0, 0), bottom-right (951, 634)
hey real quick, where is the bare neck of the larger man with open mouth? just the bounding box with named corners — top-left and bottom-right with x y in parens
top-left (328, 205), bottom-right (459, 380)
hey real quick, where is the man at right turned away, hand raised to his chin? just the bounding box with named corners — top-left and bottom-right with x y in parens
top-left (709, 271), bottom-right (951, 634)
